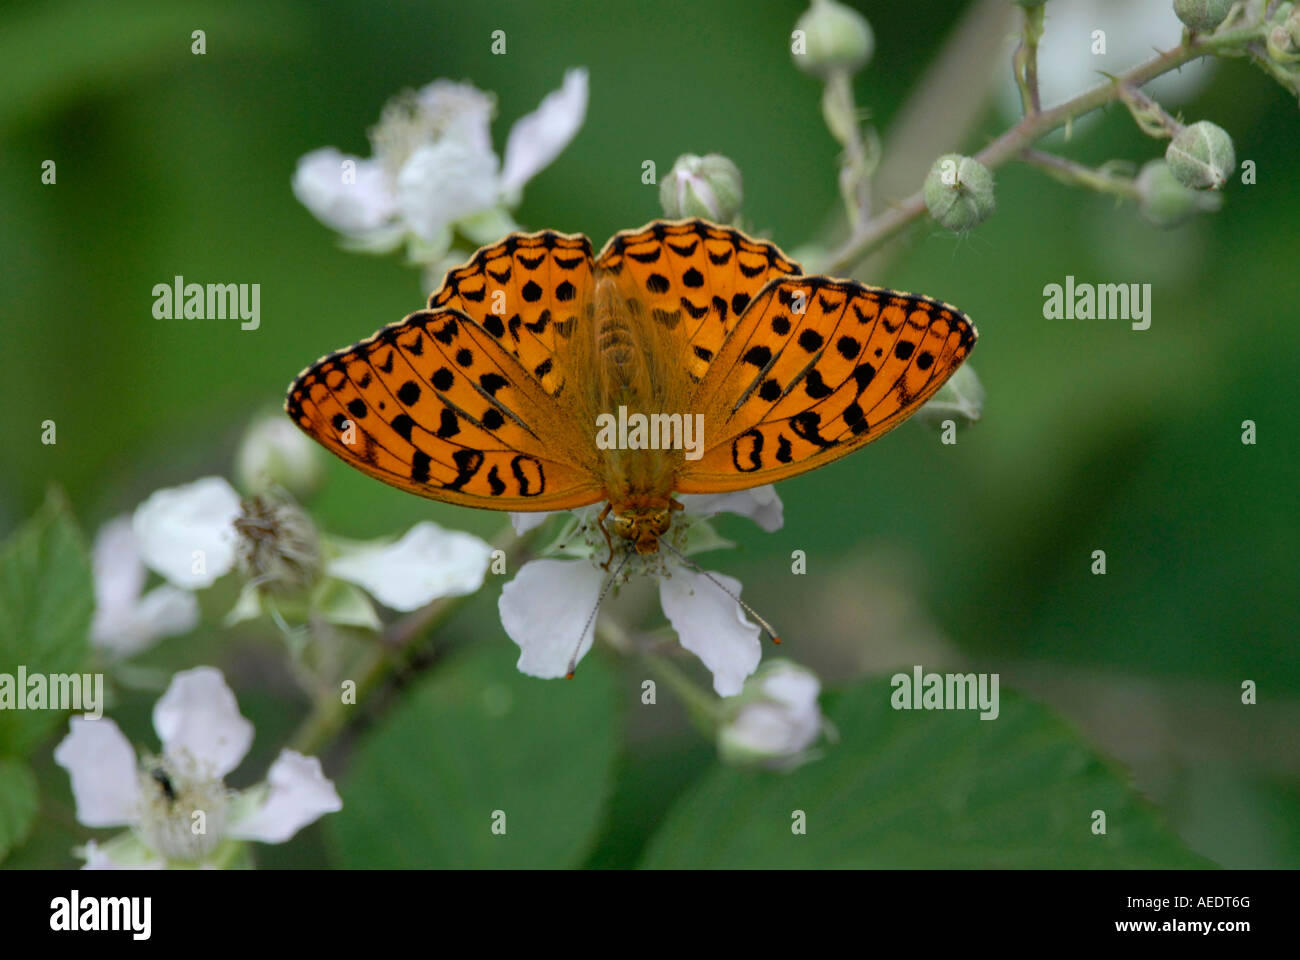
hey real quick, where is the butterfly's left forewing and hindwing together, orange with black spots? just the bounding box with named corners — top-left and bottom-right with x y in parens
top-left (285, 230), bottom-right (603, 510)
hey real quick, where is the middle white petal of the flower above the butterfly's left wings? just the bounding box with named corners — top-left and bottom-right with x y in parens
top-left (398, 139), bottom-right (498, 239)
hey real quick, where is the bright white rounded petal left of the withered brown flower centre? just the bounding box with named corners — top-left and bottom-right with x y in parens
top-left (131, 476), bottom-right (239, 591)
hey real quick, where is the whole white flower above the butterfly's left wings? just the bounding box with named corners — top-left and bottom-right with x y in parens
top-left (294, 68), bottom-right (588, 264)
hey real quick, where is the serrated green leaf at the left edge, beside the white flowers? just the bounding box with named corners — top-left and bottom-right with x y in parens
top-left (0, 493), bottom-right (95, 756)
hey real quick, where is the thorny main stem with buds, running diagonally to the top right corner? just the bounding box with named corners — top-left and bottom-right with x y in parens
top-left (822, 22), bottom-right (1262, 274)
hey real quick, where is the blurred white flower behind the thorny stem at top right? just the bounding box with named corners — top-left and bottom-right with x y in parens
top-left (998, 0), bottom-right (1213, 129)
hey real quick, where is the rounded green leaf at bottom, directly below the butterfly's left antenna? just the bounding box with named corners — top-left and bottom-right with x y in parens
top-left (326, 645), bottom-right (619, 869)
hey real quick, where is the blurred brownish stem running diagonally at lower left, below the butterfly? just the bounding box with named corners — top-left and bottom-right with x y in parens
top-left (291, 528), bottom-right (536, 754)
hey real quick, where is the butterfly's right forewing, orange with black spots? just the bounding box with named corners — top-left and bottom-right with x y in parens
top-left (676, 277), bottom-right (976, 493)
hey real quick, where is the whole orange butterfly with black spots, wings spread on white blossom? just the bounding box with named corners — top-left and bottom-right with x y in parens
top-left (285, 220), bottom-right (976, 558)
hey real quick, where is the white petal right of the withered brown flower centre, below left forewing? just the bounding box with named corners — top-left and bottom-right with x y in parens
top-left (328, 520), bottom-right (491, 613)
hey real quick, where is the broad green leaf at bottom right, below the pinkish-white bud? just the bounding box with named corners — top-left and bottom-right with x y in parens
top-left (644, 679), bottom-right (1210, 868)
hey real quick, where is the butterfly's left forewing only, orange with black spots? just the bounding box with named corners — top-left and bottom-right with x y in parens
top-left (286, 310), bottom-right (601, 510)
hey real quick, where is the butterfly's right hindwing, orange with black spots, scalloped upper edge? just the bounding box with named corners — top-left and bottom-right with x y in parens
top-left (595, 220), bottom-right (802, 382)
